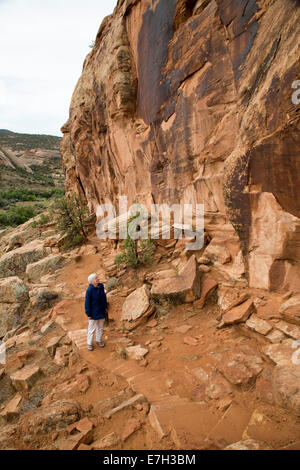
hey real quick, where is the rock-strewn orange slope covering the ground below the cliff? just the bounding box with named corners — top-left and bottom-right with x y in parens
top-left (0, 221), bottom-right (300, 450)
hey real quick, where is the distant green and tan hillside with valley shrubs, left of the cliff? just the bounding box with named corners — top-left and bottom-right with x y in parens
top-left (0, 129), bottom-right (65, 230)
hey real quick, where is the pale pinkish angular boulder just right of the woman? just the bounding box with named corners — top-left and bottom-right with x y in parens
top-left (121, 285), bottom-right (150, 321)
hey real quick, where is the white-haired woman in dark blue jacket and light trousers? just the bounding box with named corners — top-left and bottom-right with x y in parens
top-left (85, 274), bottom-right (107, 351)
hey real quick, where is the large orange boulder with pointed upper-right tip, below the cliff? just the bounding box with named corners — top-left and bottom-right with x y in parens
top-left (151, 255), bottom-right (201, 302)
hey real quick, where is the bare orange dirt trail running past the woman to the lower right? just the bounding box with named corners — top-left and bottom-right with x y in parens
top-left (47, 241), bottom-right (300, 449)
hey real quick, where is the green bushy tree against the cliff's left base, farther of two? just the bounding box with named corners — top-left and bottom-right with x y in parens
top-left (50, 194), bottom-right (88, 251)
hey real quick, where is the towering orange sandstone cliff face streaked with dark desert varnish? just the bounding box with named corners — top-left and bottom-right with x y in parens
top-left (62, 0), bottom-right (300, 292)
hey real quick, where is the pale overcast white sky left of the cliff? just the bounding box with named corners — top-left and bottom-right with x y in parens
top-left (0, 0), bottom-right (117, 135)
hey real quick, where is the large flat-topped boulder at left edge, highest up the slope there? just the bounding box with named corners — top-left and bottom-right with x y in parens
top-left (0, 240), bottom-right (49, 277)
